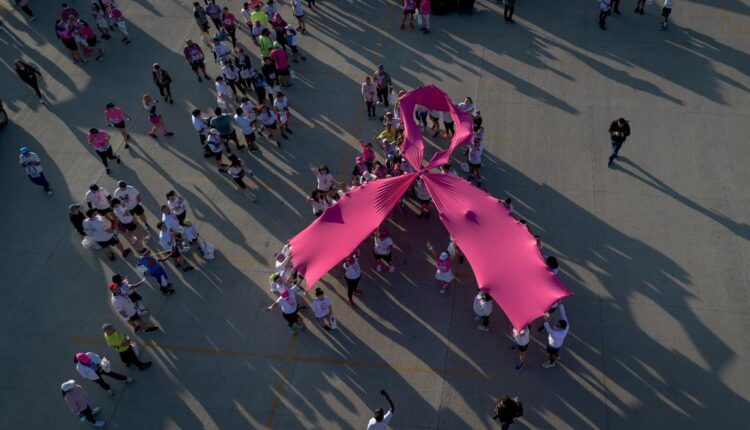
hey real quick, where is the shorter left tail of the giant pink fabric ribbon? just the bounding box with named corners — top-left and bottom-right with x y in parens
top-left (289, 173), bottom-right (417, 290)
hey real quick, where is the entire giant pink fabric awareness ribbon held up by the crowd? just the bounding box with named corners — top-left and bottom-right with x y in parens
top-left (289, 85), bottom-right (571, 330)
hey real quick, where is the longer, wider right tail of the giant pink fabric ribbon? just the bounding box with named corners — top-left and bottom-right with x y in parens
top-left (422, 173), bottom-right (572, 330)
